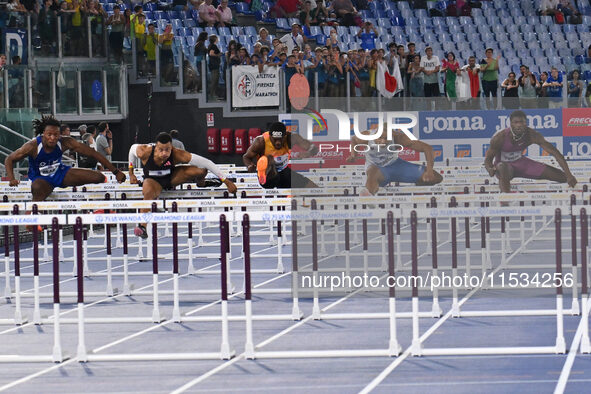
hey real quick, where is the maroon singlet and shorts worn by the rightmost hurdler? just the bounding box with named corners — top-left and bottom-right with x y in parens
top-left (494, 128), bottom-right (546, 179)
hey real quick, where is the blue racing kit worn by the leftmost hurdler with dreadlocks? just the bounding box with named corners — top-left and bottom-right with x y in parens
top-left (29, 136), bottom-right (71, 187)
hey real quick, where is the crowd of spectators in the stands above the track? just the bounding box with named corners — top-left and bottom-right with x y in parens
top-left (3, 0), bottom-right (591, 108)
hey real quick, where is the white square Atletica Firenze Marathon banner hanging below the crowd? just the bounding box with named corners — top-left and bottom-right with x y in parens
top-left (232, 66), bottom-right (280, 108)
